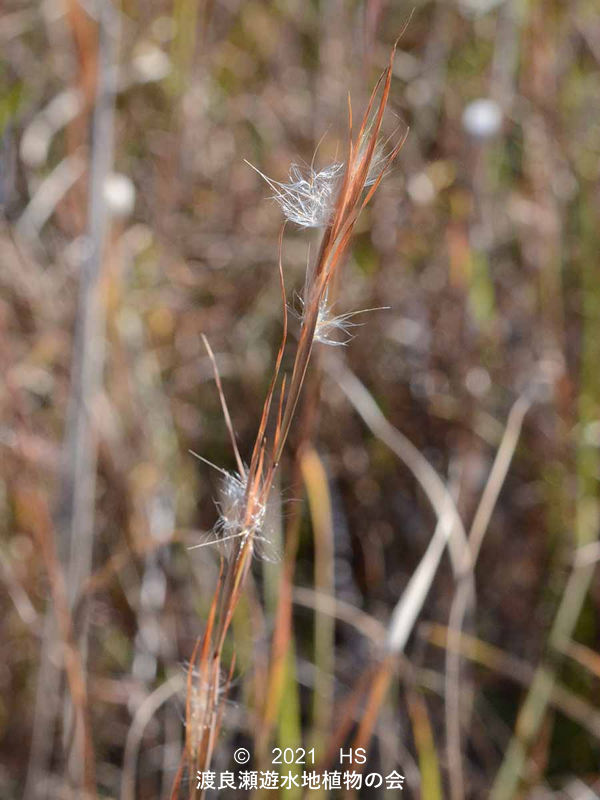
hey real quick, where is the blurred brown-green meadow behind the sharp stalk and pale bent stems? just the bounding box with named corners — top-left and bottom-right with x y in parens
top-left (0, 0), bottom-right (600, 800)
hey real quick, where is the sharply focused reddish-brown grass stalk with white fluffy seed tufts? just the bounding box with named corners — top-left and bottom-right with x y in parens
top-left (171, 45), bottom-right (406, 798)
